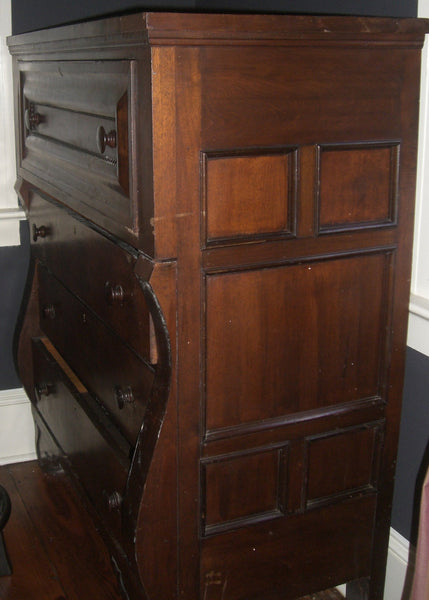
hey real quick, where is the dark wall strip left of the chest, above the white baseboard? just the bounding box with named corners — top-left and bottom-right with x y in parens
top-left (0, 221), bottom-right (30, 390)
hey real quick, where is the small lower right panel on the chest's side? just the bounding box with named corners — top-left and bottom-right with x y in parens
top-left (306, 425), bottom-right (382, 507)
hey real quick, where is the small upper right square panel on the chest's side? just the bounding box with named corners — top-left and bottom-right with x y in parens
top-left (318, 143), bottom-right (399, 232)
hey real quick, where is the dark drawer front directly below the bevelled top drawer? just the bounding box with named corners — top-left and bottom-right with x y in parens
top-left (30, 193), bottom-right (151, 360)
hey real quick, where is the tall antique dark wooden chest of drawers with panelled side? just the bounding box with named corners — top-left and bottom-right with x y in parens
top-left (9, 13), bottom-right (427, 600)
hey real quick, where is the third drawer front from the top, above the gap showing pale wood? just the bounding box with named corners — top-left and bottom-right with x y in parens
top-left (39, 268), bottom-right (154, 444)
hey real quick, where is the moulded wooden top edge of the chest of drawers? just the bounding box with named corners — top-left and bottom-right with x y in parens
top-left (8, 12), bottom-right (429, 54)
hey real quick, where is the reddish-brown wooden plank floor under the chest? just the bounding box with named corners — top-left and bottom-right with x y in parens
top-left (0, 462), bottom-right (342, 600)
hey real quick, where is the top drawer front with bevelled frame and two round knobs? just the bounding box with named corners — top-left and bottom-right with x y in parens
top-left (19, 60), bottom-right (144, 246)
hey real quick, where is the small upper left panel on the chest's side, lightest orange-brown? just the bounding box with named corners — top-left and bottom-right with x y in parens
top-left (203, 148), bottom-right (296, 243)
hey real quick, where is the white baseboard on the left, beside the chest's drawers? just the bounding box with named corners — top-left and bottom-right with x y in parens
top-left (0, 388), bottom-right (36, 465)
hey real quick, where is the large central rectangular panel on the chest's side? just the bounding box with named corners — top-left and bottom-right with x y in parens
top-left (205, 253), bottom-right (390, 431)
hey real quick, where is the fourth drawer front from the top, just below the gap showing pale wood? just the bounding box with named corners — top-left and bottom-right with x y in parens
top-left (33, 340), bottom-right (128, 535)
